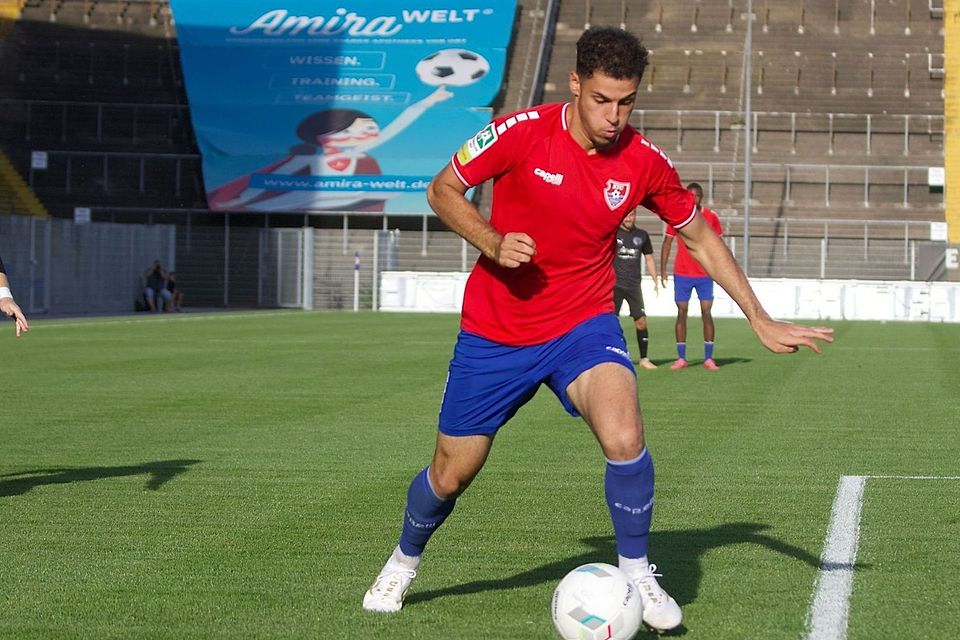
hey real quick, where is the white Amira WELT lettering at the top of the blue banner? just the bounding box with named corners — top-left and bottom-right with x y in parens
top-left (230, 8), bottom-right (493, 37)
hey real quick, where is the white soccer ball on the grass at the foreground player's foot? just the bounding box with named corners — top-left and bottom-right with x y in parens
top-left (552, 562), bottom-right (643, 640)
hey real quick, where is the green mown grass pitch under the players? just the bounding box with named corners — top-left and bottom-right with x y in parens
top-left (0, 312), bottom-right (960, 640)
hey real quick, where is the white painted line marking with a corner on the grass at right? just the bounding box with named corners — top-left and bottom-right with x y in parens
top-left (804, 475), bottom-right (960, 640)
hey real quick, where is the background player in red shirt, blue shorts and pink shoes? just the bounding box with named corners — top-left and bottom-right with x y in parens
top-left (660, 182), bottom-right (723, 371)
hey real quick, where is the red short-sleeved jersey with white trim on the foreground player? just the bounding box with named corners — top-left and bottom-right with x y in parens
top-left (451, 104), bottom-right (694, 345)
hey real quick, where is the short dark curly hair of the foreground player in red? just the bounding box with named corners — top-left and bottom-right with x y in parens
top-left (577, 27), bottom-right (647, 81)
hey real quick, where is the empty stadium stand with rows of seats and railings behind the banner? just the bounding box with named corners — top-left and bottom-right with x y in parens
top-left (0, 0), bottom-right (944, 298)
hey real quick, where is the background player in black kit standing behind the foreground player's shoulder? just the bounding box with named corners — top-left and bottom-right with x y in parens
top-left (613, 210), bottom-right (660, 369)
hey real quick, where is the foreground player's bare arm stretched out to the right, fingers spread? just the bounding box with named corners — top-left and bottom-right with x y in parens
top-left (677, 216), bottom-right (833, 353)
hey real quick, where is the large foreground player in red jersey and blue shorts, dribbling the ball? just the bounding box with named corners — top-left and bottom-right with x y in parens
top-left (363, 27), bottom-right (832, 630)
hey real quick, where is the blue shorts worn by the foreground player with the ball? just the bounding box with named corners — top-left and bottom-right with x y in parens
top-left (439, 313), bottom-right (636, 436)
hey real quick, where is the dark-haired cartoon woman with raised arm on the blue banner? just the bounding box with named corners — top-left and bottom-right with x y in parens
top-left (207, 86), bottom-right (453, 212)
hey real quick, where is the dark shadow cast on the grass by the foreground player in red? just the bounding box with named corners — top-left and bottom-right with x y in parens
top-left (406, 522), bottom-right (820, 616)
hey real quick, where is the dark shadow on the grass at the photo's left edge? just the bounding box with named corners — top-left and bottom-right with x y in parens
top-left (0, 460), bottom-right (200, 498)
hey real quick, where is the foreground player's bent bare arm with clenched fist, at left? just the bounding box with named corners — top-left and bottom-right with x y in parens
top-left (427, 165), bottom-right (537, 269)
